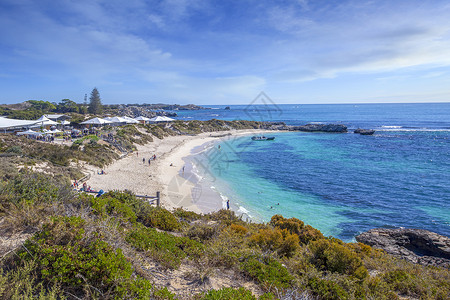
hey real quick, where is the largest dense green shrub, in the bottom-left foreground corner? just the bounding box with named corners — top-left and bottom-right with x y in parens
top-left (17, 217), bottom-right (151, 298)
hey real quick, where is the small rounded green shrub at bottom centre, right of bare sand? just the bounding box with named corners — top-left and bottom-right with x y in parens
top-left (241, 256), bottom-right (294, 290)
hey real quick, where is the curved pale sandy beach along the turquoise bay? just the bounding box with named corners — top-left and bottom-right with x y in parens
top-left (86, 130), bottom-right (274, 213)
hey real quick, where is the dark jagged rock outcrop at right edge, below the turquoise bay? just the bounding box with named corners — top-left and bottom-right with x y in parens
top-left (356, 228), bottom-right (450, 268)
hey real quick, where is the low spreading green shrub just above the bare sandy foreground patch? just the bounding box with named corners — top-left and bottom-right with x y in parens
top-left (126, 226), bottom-right (204, 268)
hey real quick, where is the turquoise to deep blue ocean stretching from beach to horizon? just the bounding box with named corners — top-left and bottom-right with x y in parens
top-left (174, 103), bottom-right (450, 242)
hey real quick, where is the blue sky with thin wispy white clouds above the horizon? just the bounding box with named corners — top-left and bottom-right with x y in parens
top-left (0, 0), bottom-right (450, 104)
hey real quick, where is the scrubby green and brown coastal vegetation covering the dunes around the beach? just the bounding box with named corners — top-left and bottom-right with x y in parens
top-left (0, 120), bottom-right (450, 299)
